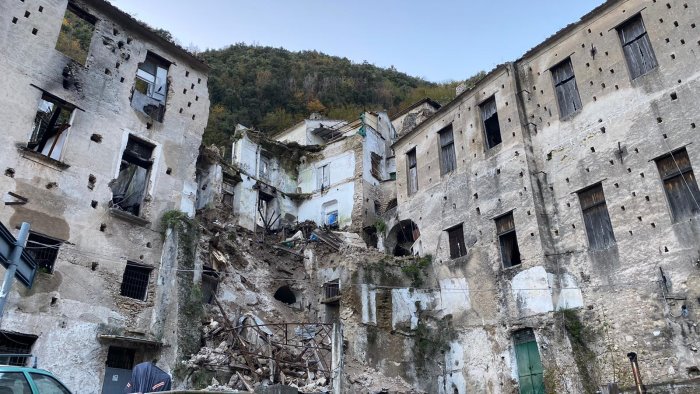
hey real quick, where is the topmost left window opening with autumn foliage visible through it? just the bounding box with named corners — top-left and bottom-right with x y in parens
top-left (56, 2), bottom-right (97, 65)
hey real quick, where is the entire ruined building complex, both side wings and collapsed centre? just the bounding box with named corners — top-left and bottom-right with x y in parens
top-left (0, 0), bottom-right (700, 393)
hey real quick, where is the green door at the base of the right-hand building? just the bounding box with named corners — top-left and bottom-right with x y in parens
top-left (514, 330), bottom-right (544, 394)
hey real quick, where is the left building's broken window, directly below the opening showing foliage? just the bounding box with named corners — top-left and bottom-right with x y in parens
top-left (27, 93), bottom-right (75, 160)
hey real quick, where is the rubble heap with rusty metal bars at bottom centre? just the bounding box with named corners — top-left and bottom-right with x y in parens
top-left (184, 300), bottom-right (333, 393)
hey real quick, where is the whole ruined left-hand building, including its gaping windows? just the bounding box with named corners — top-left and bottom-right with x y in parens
top-left (0, 0), bottom-right (209, 393)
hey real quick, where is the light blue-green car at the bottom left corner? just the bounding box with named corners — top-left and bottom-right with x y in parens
top-left (0, 365), bottom-right (71, 394)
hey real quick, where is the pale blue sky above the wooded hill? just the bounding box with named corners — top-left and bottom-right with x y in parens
top-left (111, 0), bottom-right (604, 82)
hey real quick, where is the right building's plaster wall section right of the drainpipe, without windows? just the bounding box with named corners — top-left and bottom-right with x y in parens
top-left (518, 0), bottom-right (700, 383)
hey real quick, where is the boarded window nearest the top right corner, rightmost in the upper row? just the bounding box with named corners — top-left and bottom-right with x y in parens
top-left (617, 14), bottom-right (658, 79)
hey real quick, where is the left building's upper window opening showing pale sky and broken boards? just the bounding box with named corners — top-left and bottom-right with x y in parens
top-left (131, 52), bottom-right (170, 122)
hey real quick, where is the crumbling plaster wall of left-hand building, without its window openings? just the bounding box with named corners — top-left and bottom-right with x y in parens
top-left (0, 0), bottom-right (209, 392)
